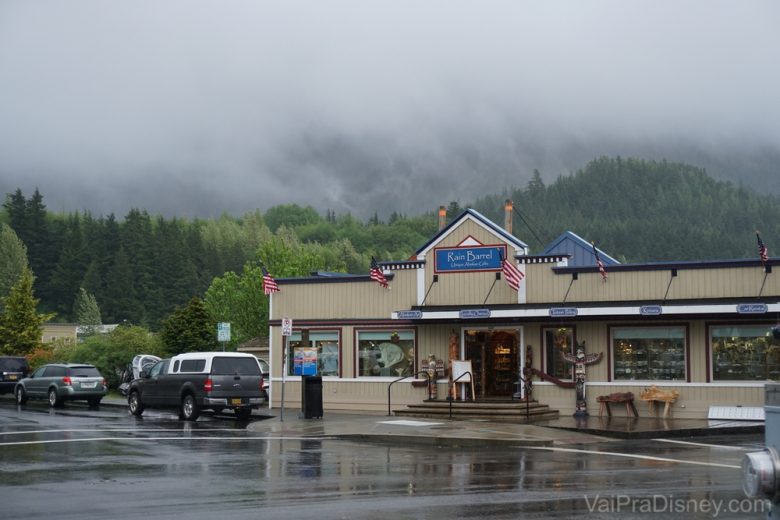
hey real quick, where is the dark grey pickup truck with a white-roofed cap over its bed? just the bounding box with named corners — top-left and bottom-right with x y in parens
top-left (127, 352), bottom-right (268, 421)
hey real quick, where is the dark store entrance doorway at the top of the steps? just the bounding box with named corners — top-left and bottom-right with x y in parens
top-left (463, 329), bottom-right (520, 399)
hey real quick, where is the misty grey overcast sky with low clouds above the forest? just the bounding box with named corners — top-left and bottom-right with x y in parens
top-left (0, 0), bottom-right (780, 218)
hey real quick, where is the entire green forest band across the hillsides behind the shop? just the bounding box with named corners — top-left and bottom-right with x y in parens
top-left (0, 157), bottom-right (780, 330)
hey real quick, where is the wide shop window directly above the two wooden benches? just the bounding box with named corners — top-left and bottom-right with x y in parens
top-left (612, 327), bottom-right (685, 381)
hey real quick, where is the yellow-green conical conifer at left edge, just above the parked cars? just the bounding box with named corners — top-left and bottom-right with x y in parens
top-left (0, 267), bottom-right (52, 356)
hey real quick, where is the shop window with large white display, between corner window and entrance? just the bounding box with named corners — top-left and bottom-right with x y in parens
top-left (357, 330), bottom-right (414, 377)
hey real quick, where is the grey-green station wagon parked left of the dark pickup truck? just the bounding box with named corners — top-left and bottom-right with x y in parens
top-left (14, 364), bottom-right (108, 406)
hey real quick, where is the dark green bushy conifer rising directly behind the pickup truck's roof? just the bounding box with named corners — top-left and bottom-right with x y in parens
top-left (160, 297), bottom-right (218, 355)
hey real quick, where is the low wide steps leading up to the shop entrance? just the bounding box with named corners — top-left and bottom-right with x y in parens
top-left (393, 399), bottom-right (558, 423)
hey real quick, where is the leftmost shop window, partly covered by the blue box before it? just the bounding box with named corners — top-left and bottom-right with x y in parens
top-left (287, 330), bottom-right (340, 376)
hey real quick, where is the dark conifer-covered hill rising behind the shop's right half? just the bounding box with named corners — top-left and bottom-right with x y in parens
top-left (475, 157), bottom-right (780, 262)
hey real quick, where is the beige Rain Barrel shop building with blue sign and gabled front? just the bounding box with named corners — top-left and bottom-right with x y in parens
top-left (269, 209), bottom-right (780, 418)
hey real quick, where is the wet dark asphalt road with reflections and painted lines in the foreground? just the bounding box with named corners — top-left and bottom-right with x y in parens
top-left (0, 402), bottom-right (765, 520)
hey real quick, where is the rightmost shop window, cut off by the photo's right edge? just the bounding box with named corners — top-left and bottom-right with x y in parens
top-left (710, 325), bottom-right (780, 381)
